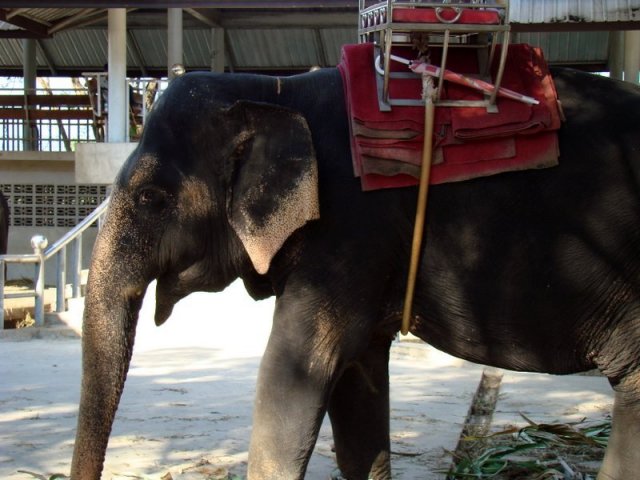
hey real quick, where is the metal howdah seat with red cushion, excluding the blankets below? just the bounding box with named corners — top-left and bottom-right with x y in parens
top-left (358, 0), bottom-right (510, 111)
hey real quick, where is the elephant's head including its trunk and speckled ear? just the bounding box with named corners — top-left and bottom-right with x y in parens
top-left (71, 75), bottom-right (319, 480)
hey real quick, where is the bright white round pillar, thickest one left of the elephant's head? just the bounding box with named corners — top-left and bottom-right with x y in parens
top-left (107, 8), bottom-right (129, 143)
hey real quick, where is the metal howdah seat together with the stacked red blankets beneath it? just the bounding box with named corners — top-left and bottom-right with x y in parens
top-left (348, 0), bottom-right (560, 190)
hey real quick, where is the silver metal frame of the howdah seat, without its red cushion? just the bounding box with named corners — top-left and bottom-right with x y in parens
top-left (358, 0), bottom-right (510, 112)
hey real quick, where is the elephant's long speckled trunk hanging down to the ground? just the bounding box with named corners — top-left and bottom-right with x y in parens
top-left (71, 220), bottom-right (146, 480)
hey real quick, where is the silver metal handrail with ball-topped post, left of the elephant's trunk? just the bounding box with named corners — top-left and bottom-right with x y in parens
top-left (0, 197), bottom-right (109, 329)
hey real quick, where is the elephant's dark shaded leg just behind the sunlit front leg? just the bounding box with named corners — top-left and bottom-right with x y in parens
top-left (328, 338), bottom-right (391, 480)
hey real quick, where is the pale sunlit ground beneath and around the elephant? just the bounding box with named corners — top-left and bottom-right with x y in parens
top-left (0, 284), bottom-right (611, 480)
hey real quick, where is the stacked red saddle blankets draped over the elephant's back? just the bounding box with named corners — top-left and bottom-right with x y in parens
top-left (338, 43), bottom-right (561, 190)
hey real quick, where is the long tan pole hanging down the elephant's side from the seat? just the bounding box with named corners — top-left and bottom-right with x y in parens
top-left (400, 76), bottom-right (436, 335)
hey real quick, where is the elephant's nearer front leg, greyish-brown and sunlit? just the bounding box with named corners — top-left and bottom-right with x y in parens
top-left (248, 299), bottom-right (356, 480)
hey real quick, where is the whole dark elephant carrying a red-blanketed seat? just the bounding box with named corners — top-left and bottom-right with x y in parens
top-left (71, 64), bottom-right (640, 480)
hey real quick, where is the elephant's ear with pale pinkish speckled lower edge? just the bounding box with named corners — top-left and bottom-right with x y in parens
top-left (227, 101), bottom-right (319, 274)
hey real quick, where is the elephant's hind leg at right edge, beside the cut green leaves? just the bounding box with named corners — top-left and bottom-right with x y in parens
top-left (598, 380), bottom-right (640, 480)
